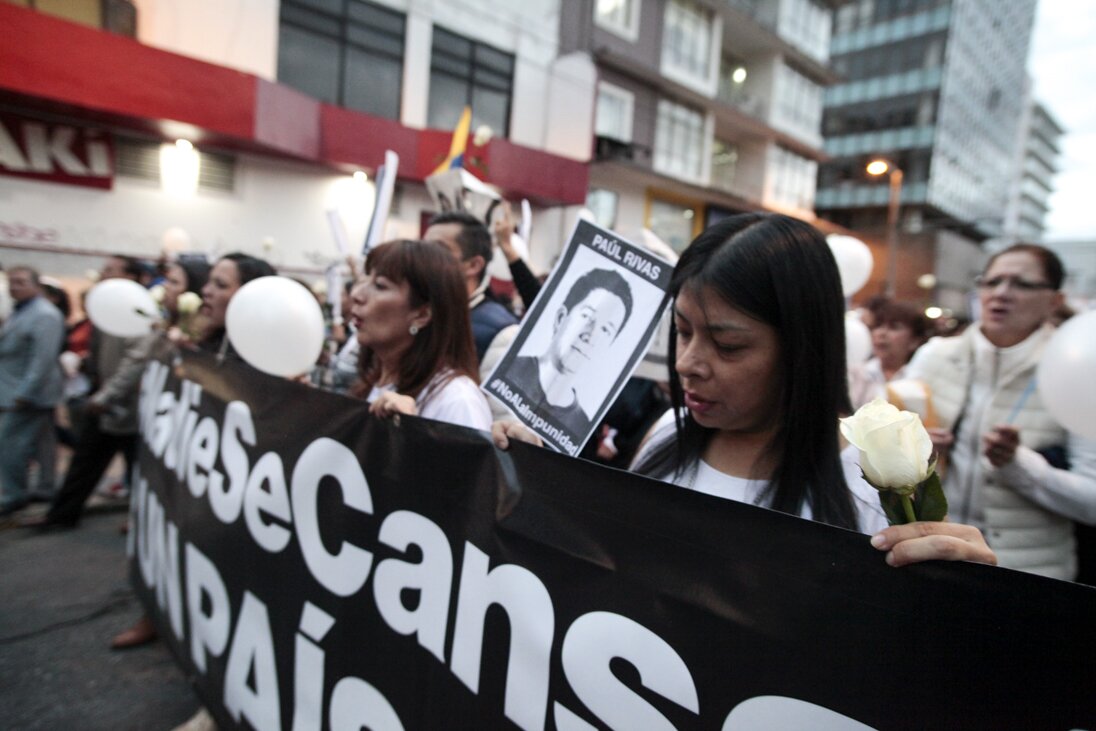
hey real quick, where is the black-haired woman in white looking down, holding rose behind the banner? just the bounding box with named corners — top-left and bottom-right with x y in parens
top-left (494, 214), bottom-right (995, 566)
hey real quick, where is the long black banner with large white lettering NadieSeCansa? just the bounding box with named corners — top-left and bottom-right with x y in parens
top-left (129, 346), bottom-right (1096, 731)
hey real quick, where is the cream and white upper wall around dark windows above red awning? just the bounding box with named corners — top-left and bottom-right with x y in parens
top-left (135, 0), bottom-right (595, 160)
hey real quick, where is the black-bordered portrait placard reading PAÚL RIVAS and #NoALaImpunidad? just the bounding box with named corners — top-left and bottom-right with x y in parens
top-left (482, 219), bottom-right (673, 455)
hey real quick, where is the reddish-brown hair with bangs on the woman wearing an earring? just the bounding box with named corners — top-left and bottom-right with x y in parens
top-left (352, 239), bottom-right (479, 398)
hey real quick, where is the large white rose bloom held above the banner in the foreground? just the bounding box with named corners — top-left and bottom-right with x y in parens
top-left (841, 399), bottom-right (933, 494)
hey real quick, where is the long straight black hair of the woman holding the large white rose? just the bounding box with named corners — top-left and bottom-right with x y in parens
top-left (636, 214), bottom-right (857, 529)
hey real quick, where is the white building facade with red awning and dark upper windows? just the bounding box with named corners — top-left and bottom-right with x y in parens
top-left (0, 0), bottom-right (596, 275)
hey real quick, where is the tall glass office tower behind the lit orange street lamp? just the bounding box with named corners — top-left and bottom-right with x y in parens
top-left (815, 0), bottom-right (1036, 312)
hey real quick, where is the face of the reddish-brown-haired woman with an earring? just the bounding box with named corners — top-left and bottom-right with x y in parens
top-left (351, 274), bottom-right (421, 353)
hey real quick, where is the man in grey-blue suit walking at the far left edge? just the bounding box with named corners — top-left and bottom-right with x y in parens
top-left (0, 266), bottom-right (65, 517)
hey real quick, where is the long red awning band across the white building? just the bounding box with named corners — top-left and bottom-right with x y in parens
top-left (0, 2), bottom-right (589, 205)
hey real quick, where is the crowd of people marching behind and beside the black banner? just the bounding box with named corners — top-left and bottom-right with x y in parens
top-left (0, 213), bottom-right (1096, 727)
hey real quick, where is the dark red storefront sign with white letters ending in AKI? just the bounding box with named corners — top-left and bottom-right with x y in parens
top-left (0, 114), bottom-right (114, 190)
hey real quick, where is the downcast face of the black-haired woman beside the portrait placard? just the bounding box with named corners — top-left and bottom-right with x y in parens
top-left (674, 287), bottom-right (783, 433)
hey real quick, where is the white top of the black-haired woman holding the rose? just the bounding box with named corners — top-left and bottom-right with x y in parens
top-left (635, 410), bottom-right (888, 535)
